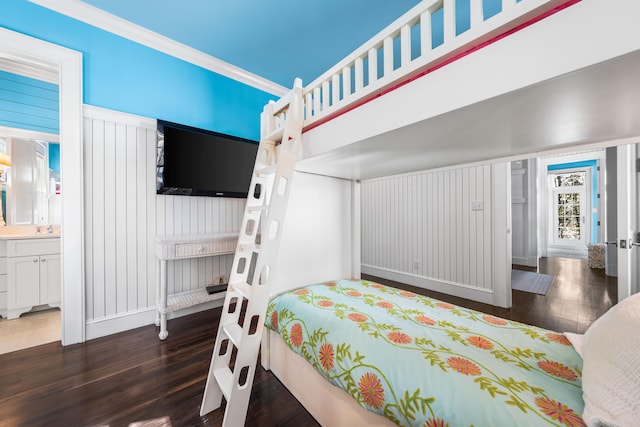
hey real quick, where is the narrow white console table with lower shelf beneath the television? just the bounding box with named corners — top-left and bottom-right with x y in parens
top-left (156, 232), bottom-right (238, 340)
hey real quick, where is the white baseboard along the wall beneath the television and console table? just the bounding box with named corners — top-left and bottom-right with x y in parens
top-left (85, 299), bottom-right (224, 340)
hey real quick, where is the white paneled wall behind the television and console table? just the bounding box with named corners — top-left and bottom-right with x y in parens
top-left (84, 107), bottom-right (245, 328)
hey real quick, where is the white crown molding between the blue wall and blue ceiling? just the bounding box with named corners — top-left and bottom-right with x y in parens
top-left (29, 0), bottom-right (289, 96)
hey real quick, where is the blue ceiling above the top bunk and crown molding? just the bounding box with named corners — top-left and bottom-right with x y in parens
top-left (83, 0), bottom-right (420, 88)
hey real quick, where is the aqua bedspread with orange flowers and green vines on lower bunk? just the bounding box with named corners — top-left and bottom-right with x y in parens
top-left (265, 280), bottom-right (584, 427)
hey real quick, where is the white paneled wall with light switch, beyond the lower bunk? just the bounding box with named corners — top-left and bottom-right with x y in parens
top-left (362, 165), bottom-right (508, 303)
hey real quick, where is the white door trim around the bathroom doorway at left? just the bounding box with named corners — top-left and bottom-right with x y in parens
top-left (0, 27), bottom-right (85, 345)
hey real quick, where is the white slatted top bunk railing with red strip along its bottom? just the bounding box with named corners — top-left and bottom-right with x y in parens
top-left (263, 0), bottom-right (580, 141)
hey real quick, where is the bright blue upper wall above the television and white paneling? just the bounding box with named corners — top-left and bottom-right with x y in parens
top-left (0, 0), bottom-right (276, 140)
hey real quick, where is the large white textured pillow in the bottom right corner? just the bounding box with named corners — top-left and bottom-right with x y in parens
top-left (582, 294), bottom-right (640, 427)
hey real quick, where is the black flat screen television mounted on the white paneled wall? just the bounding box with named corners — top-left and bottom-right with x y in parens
top-left (156, 120), bottom-right (258, 198)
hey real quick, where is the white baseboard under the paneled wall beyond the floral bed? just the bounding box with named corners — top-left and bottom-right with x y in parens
top-left (362, 264), bottom-right (495, 305)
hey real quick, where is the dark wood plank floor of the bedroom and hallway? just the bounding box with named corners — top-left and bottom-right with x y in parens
top-left (0, 259), bottom-right (617, 427)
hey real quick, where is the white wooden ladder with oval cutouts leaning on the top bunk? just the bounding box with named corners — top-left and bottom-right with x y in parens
top-left (200, 79), bottom-right (303, 427)
